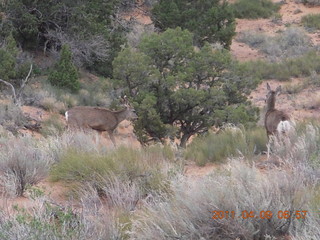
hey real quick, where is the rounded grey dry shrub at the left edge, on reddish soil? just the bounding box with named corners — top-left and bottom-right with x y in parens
top-left (0, 138), bottom-right (51, 196)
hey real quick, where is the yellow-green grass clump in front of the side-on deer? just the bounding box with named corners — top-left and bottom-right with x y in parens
top-left (50, 147), bottom-right (177, 201)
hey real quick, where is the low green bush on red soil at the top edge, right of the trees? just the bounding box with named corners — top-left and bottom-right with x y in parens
top-left (232, 0), bottom-right (280, 19)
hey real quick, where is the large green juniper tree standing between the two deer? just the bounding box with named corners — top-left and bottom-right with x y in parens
top-left (114, 28), bottom-right (257, 146)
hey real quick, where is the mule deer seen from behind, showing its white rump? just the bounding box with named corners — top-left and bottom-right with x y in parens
top-left (264, 83), bottom-right (292, 157)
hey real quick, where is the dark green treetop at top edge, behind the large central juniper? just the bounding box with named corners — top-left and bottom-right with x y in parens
top-left (152, 0), bottom-right (235, 48)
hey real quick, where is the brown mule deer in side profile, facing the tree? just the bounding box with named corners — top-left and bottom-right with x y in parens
top-left (65, 98), bottom-right (138, 146)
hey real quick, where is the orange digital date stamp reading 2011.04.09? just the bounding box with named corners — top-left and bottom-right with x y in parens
top-left (211, 210), bottom-right (308, 219)
